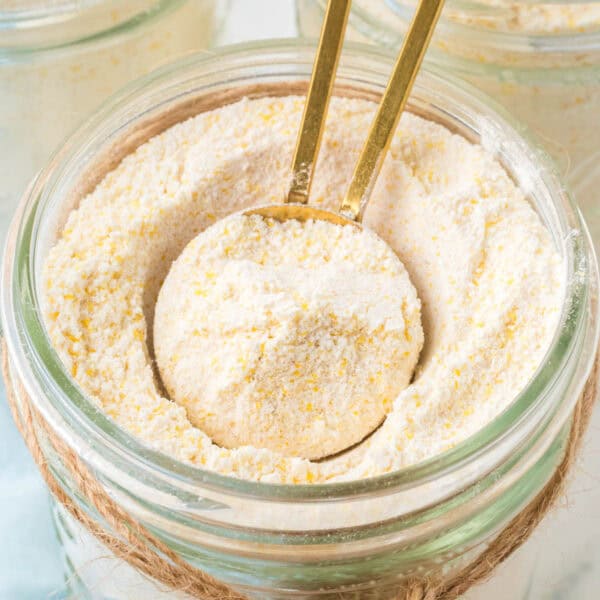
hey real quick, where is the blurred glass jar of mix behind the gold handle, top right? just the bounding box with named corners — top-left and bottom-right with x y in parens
top-left (297, 0), bottom-right (600, 243)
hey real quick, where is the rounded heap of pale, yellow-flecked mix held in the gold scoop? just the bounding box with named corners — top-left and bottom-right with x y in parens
top-left (154, 215), bottom-right (423, 458)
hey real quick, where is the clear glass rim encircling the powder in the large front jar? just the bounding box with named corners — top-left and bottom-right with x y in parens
top-left (0, 40), bottom-right (599, 501)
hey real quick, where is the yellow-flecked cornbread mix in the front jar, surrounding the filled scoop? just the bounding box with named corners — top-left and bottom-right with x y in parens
top-left (44, 97), bottom-right (565, 483)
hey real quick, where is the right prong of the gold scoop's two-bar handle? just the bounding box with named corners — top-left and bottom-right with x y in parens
top-left (340, 0), bottom-right (444, 222)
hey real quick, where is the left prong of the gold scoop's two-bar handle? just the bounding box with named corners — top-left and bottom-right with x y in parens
top-left (287, 0), bottom-right (351, 204)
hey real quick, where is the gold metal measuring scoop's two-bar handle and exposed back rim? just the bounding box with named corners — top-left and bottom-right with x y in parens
top-left (243, 0), bottom-right (444, 227)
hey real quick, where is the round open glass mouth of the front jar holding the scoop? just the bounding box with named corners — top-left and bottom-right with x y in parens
top-left (1, 40), bottom-right (598, 501)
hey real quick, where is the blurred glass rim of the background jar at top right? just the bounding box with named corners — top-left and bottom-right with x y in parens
top-left (350, 0), bottom-right (600, 55)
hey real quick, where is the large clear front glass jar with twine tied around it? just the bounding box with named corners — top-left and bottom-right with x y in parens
top-left (0, 41), bottom-right (599, 600)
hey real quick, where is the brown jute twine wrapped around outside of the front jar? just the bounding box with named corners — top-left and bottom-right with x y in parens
top-left (2, 343), bottom-right (599, 600)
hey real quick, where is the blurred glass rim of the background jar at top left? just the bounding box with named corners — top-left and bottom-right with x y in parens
top-left (0, 0), bottom-right (187, 54)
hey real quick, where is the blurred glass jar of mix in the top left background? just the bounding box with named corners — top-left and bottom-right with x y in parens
top-left (0, 0), bottom-right (224, 244)
